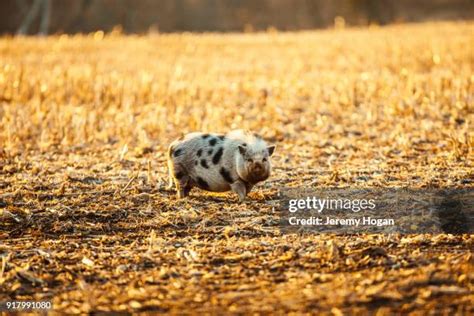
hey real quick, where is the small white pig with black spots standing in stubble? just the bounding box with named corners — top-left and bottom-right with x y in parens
top-left (168, 130), bottom-right (275, 202)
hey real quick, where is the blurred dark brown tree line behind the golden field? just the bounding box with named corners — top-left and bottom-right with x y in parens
top-left (0, 0), bottom-right (474, 34)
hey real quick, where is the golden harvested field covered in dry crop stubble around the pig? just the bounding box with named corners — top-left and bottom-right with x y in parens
top-left (0, 22), bottom-right (474, 315)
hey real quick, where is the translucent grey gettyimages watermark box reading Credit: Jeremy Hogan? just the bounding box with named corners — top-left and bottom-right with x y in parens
top-left (279, 188), bottom-right (474, 234)
